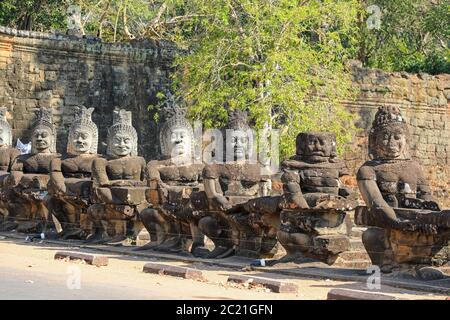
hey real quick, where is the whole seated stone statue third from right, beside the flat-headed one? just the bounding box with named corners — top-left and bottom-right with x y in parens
top-left (194, 110), bottom-right (276, 258)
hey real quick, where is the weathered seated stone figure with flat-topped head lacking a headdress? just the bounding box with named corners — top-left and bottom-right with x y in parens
top-left (278, 132), bottom-right (356, 264)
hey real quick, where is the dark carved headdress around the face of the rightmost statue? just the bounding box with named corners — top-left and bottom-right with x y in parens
top-left (369, 106), bottom-right (410, 156)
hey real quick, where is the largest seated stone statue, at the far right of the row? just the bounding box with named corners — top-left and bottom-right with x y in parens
top-left (355, 107), bottom-right (450, 272)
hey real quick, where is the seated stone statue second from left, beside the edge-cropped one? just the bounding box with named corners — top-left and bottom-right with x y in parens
top-left (7, 108), bottom-right (60, 232)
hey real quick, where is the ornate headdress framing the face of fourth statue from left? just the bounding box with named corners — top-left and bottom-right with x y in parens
top-left (106, 108), bottom-right (138, 156)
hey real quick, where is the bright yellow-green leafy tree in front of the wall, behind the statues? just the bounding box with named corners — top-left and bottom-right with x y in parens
top-left (153, 0), bottom-right (358, 157)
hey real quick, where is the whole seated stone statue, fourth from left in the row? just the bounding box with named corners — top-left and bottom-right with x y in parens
top-left (88, 109), bottom-right (148, 242)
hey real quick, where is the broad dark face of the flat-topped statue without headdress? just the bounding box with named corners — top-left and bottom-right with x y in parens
top-left (297, 134), bottom-right (336, 161)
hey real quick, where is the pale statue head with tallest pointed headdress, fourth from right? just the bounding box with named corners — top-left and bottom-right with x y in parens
top-left (159, 93), bottom-right (194, 159)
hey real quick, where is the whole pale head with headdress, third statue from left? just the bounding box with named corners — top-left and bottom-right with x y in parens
top-left (67, 106), bottom-right (98, 154)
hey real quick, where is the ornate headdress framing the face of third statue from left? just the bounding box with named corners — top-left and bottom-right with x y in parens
top-left (67, 106), bottom-right (98, 154)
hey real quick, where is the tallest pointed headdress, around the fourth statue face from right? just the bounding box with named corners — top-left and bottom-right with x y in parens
top-left (159, 92), bottom-right (194, 157)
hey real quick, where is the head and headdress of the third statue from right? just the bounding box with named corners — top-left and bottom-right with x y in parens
top-left (225, 109), bottom-right (251, 161)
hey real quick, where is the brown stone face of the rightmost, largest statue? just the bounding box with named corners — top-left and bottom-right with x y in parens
top-left (376, 129), bottom-right (407, 159)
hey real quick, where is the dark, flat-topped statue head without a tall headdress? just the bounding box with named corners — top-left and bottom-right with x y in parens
top-left (295, 132), bottom-right (337, 163)
